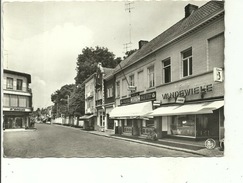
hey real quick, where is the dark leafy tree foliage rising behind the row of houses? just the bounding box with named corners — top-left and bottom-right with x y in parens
top-left (51, 46), bottom-right (121, 117)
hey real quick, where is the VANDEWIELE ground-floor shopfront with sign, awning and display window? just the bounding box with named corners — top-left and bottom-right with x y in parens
top-left (151, 72), bottom-right (224, 139)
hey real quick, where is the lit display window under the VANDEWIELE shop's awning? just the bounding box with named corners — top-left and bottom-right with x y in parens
top-left (171, 115), bottom-right (196, 137)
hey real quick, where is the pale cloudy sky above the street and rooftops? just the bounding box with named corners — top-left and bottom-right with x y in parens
top-left (2, 1), bottom-right (207, 110)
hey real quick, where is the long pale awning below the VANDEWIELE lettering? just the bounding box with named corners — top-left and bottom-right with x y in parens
top-left (150, 101), bottom-right (224, 116)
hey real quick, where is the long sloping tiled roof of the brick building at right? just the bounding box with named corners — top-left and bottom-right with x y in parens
top-left (114, 1), bottom-right (224, 73)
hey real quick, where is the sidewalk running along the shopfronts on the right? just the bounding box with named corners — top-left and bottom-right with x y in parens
top-left (86, 131), bottom-right (224, 157)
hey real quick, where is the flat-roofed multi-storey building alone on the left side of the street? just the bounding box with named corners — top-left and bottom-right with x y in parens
top-left (3, 69), bottom-right (33, 129)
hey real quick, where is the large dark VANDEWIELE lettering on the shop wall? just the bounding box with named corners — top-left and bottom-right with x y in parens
top-left (162, 84), bottom-right (213, 99)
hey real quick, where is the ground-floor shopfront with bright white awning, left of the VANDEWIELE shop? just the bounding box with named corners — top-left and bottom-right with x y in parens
top-left (110, 92), bottom-right (156, 136)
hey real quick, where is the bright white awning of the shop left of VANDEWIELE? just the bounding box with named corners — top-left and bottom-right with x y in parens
top-left (110, 102), bottom-right (153, 119)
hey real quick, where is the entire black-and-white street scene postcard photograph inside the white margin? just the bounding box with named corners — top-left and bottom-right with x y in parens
top-left (1, 1), bottom-right (227, 159)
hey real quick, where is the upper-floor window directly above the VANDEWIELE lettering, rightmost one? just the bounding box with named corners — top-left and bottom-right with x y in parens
top-left (182, 49), bottom-right (192, 77)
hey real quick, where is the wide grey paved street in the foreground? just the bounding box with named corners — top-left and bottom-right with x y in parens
top-left (3, 124), bottom-right (200, 158)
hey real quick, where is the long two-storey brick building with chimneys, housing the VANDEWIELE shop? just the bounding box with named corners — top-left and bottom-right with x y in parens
top-left (110, 1), bottom-right (225, 139)
